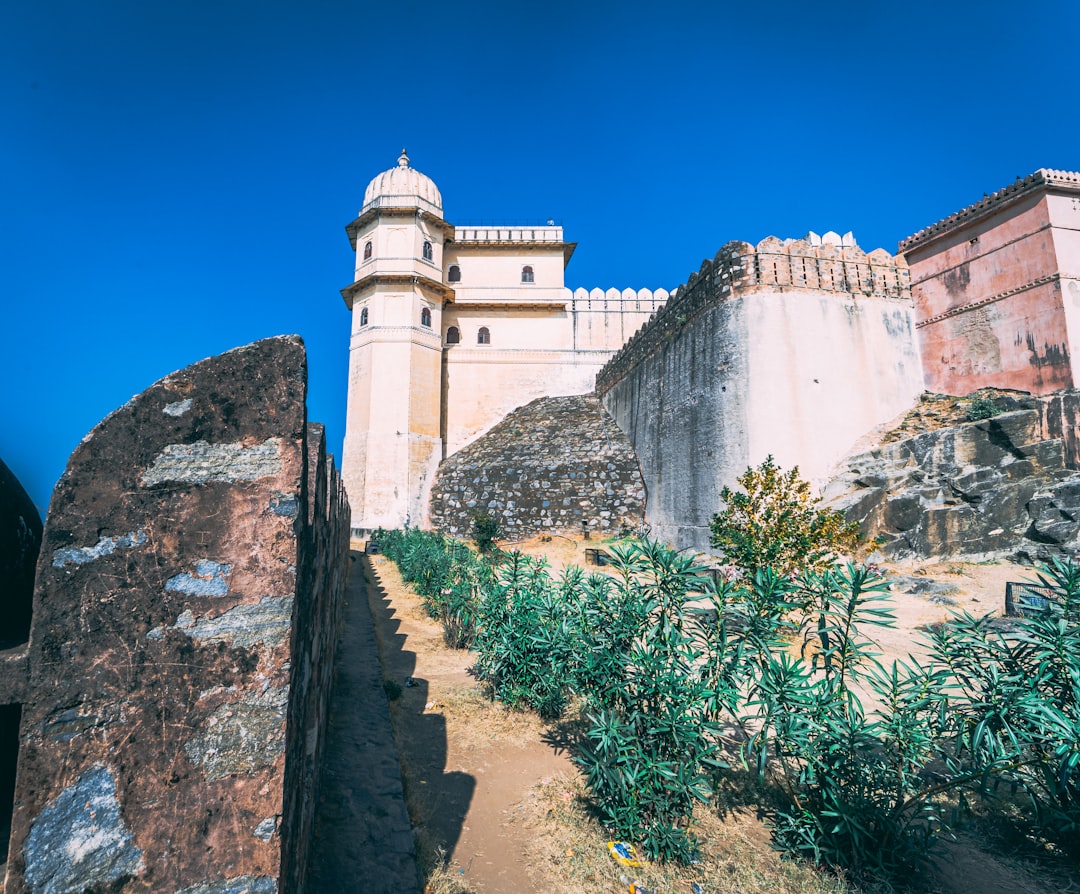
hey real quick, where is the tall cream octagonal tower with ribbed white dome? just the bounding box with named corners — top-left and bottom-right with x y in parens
top-left (341, 149), bottom-right (454, 530)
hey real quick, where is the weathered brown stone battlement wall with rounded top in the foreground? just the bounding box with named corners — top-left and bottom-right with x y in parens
top-left (4, 338), bottom-right (349, 894)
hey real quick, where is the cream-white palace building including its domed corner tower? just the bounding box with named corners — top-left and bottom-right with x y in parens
top-left (341, 150), bottom-right (669, 530)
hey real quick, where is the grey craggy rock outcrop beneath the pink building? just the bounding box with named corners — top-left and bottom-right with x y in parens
top-left (823, 396), bottom-right (1080, 558)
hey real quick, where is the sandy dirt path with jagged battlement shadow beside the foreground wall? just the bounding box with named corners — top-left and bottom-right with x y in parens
top-left (363, 556), bottom-right (573, 894)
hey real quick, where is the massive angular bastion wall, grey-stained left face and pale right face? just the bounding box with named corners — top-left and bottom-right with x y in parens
top-left (596, 238), bottom-right (922, 548)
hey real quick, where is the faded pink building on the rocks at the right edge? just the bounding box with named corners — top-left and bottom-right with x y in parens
top-left (900, 168), bottom-right (1080, 394)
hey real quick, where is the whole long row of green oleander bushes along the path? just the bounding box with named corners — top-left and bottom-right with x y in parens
top-left (383, 531), bottom-right (1080, 881)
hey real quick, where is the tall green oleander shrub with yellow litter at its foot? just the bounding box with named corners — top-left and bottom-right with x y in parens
top-left (575, 542), bottom-right (723, 862)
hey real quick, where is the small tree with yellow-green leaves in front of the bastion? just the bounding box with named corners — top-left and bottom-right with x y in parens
top-left (710, 455), bottom-right (859, 575)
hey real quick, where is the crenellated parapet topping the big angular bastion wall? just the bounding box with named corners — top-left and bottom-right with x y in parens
top-left (596, 233), bottom-right (912, 394)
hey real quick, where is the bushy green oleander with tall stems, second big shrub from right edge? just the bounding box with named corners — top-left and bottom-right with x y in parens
top-left (743, 566), bottom-right (944, 878)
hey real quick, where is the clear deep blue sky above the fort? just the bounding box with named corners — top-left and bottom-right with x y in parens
top-left (0, 0), bottom-right (1080, 509)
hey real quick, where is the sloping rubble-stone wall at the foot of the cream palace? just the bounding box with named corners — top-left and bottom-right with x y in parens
top-left (430, 394), bottom-right (645, 540)
